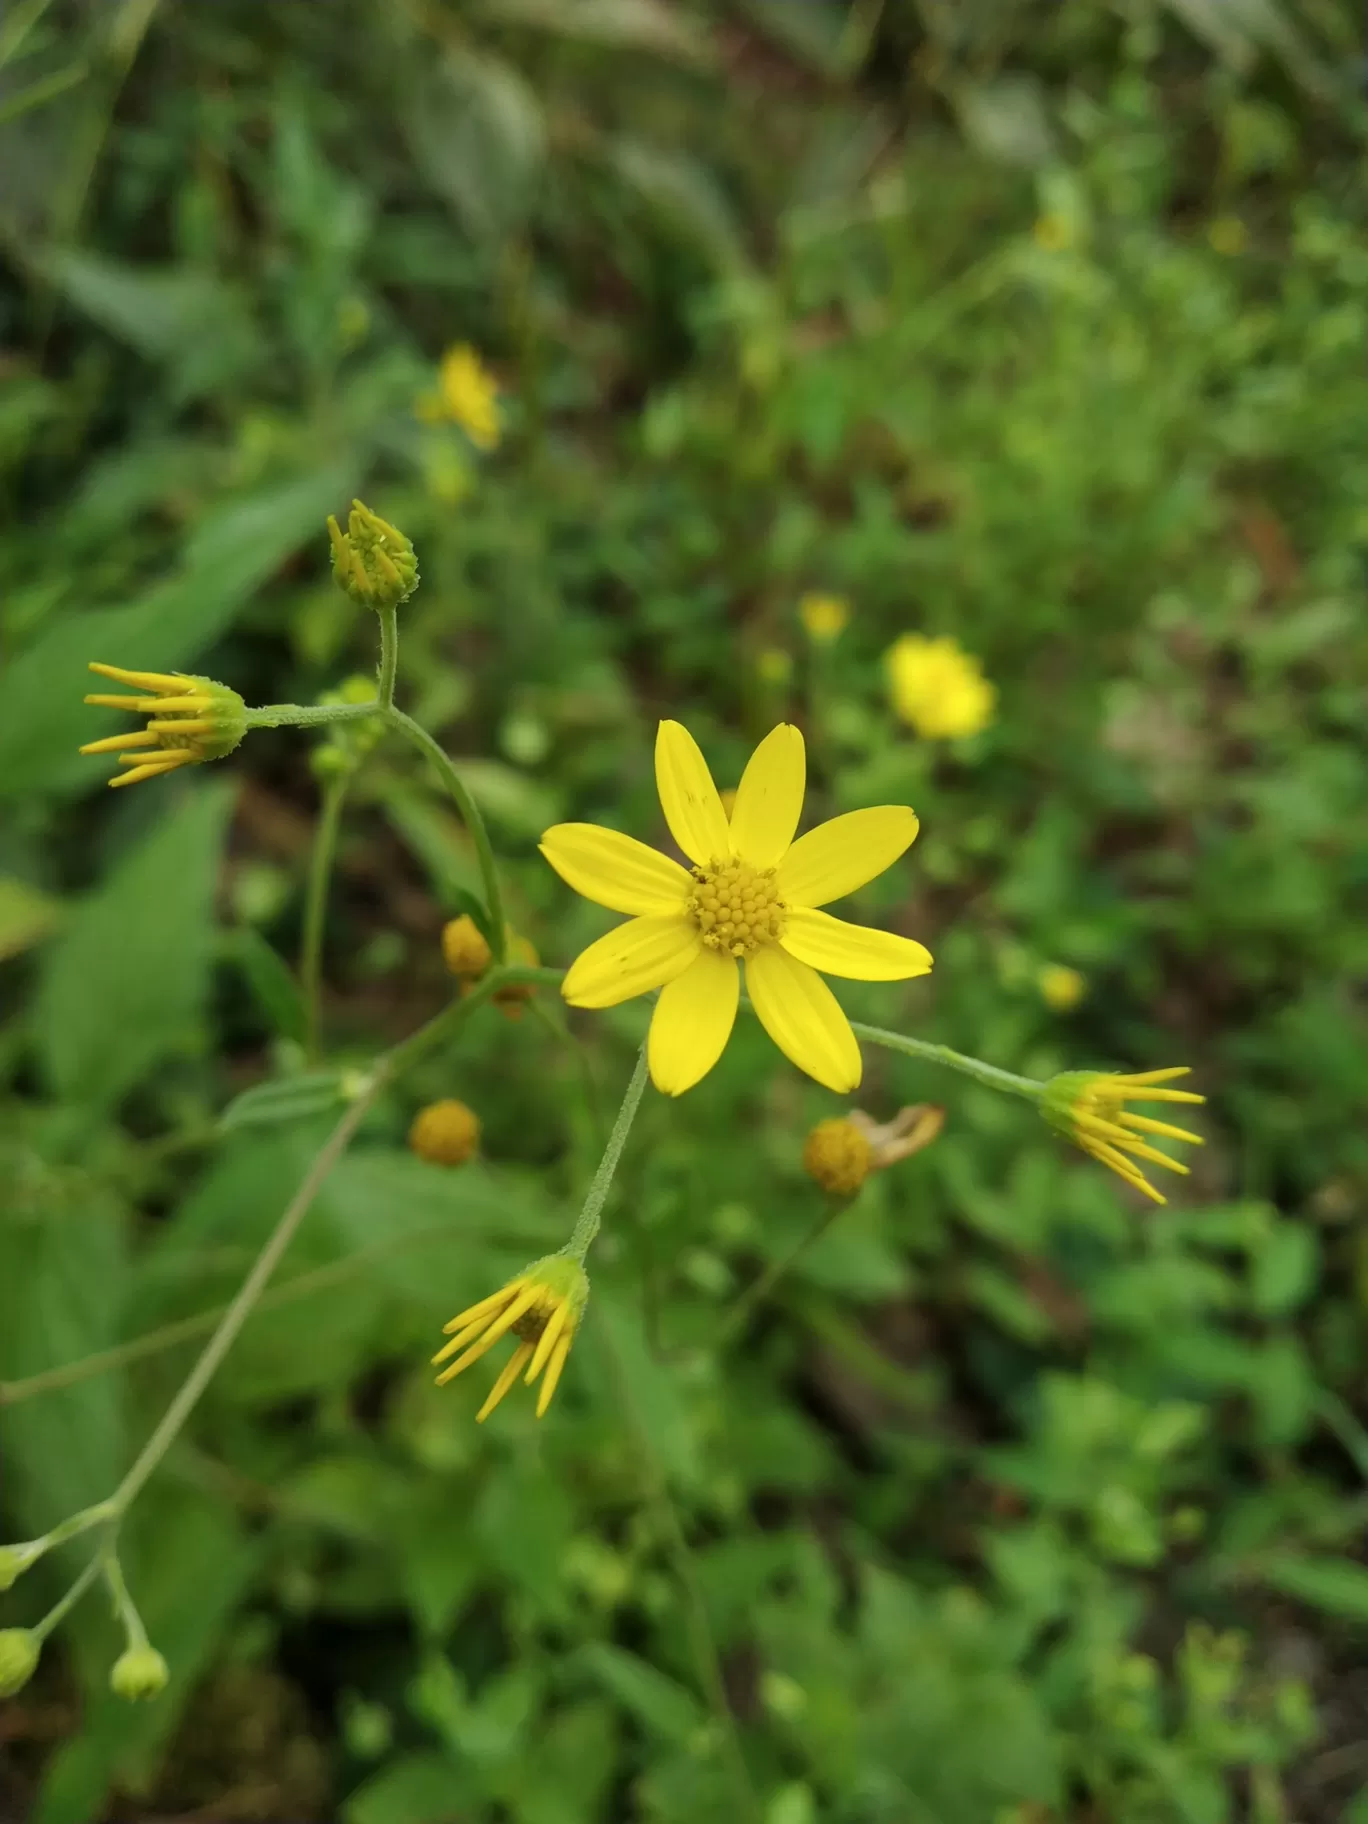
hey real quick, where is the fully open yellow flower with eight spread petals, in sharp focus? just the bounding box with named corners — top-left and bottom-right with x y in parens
top-left (542, 722), bottom-right (930, 1096)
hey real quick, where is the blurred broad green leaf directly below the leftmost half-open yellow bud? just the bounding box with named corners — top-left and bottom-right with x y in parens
top-left (36, 781), bottom-right (232, 1105)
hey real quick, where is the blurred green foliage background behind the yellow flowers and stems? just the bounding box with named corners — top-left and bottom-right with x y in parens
top-left (0, 0), bottom-right (1368, 1824)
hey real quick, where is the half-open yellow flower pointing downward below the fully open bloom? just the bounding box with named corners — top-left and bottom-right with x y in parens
top-left (432, 1255), bottom-right (589, 1425)
